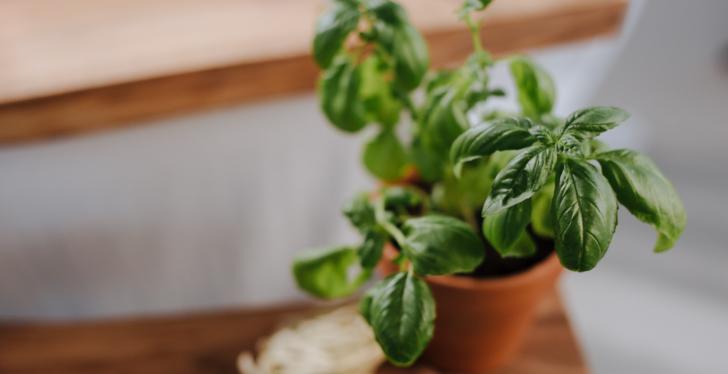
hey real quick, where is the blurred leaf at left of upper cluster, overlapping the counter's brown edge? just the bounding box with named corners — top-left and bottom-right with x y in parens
top-left (319, 55), bottom-right (367, 132)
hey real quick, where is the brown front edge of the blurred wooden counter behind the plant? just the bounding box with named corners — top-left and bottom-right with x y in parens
top-left (0, 0), bottom-right (628, 144)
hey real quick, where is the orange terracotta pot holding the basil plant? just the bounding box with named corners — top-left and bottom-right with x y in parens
top-left (378, 244), bottom-right (562, 373)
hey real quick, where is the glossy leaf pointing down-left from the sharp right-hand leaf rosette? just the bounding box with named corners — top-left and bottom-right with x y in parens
top-left (483, 144), bottom-right (556, 216)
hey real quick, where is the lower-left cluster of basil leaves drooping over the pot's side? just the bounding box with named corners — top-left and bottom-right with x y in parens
top-left (293, 186), bottom-right (485, 366)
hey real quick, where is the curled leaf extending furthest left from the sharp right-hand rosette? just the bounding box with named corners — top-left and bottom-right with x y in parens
top-left (450, 117), bottom-right (535, 176)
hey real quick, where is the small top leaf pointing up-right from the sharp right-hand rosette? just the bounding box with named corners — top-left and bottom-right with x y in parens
top-left (562, 106), bottom-right (629, 139)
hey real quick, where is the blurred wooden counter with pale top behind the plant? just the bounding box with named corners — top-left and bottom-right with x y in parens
top-left (0, 0), bottom-right (628, 144)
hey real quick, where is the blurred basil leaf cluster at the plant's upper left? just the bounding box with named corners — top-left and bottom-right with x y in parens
top-left (313, 0), bottom-right (430, 180)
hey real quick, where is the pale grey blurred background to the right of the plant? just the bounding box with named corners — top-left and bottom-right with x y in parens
top-left (564, 0), bottom-right (728, 374)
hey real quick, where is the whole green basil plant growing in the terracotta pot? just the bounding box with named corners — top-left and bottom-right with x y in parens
top-left (293, 0), bottom-right (685, 366)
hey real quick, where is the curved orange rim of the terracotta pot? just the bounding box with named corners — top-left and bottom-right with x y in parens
top-left (425, 250), bottom-right (562, 290)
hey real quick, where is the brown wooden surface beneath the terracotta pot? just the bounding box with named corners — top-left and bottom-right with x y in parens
top-left (0, 294), bottom-right (587, 374)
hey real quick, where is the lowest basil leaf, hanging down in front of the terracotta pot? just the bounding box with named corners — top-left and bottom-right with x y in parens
top-left (359, 272), bottom-right (435, 366)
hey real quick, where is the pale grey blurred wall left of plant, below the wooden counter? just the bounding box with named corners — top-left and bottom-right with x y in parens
top-left (0, 96), bottom-right (368, 318)
